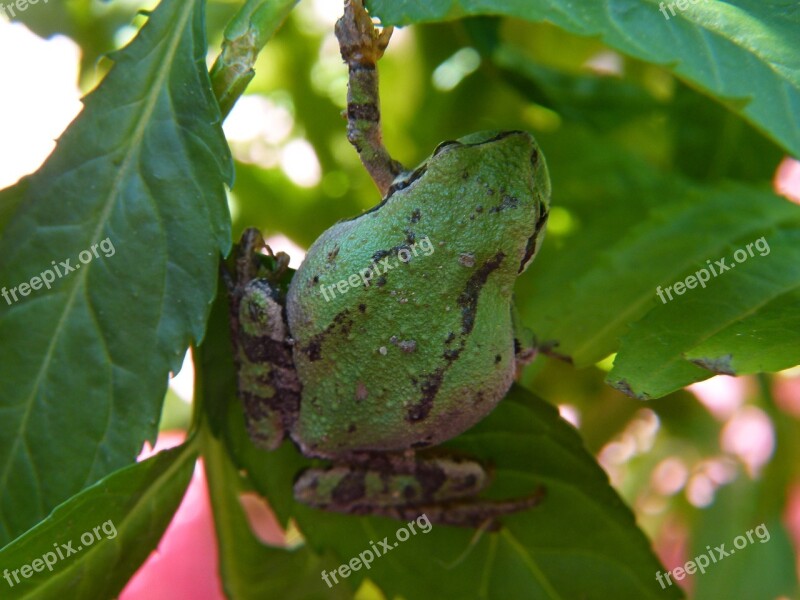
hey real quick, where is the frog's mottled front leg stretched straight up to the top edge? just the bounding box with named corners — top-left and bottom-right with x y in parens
top-left (336, 0), bottom-right (404, 196)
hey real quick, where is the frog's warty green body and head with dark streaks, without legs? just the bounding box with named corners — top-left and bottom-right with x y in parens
top-left (287, 131), bottom-right (550, 458)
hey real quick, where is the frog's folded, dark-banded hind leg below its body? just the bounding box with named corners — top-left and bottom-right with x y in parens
top-left (294, 455), bottom-right (544, 529)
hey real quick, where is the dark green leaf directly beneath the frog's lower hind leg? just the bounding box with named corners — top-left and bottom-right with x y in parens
top-left (230, 388), bottom-right (681, 600)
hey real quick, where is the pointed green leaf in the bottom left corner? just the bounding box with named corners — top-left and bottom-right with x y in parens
top-left (0, 444), bottom-right (196, 600)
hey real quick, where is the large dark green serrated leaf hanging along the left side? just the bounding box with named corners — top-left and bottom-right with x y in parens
top-left (0, 0), bottom-right (231, 543)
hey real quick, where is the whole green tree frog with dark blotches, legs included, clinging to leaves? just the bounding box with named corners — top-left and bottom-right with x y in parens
top-left (225, 0), bottom-right (550, 526)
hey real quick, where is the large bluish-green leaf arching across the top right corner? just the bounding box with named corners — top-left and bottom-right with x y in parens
top-left (368, 0), bottom-right (800, 156)
